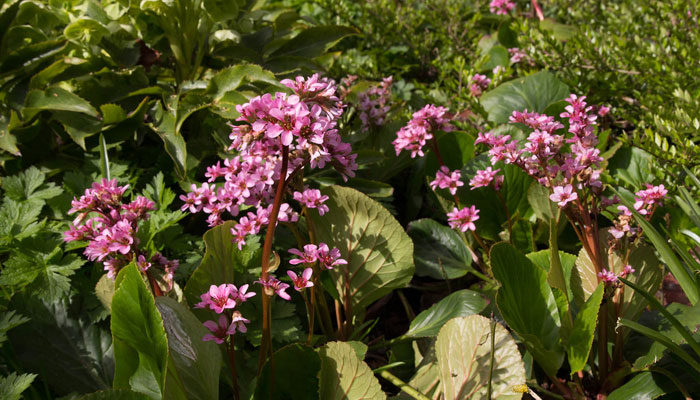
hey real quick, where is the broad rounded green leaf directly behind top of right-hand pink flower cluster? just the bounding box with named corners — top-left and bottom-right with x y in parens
top-left (481, 71), bottom-right (569, 124)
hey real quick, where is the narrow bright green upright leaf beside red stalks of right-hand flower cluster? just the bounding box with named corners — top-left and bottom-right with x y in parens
top-left (567, 284), bottom-right (605, 375)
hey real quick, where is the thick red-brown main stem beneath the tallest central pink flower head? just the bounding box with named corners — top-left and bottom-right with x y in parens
top-left (258, 146), bottom-right (289, 376)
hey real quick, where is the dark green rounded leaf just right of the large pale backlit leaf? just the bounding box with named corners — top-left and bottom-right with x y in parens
top-left (407, 218), bottom-right (472, 279)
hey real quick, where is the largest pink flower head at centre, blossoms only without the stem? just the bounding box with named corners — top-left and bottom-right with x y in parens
top-left (180, 75), bottom-right (357, 248)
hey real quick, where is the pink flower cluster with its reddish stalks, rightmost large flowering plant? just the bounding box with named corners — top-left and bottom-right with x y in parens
top-left (472, 94), bottom-right (666, 384)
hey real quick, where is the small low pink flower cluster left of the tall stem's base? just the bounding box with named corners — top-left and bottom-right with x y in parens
top-left (194, 283), bottom-right (255, 344)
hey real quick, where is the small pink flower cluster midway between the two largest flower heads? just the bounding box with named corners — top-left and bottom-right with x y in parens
top-left (392, 104), bottom-right (453, 158)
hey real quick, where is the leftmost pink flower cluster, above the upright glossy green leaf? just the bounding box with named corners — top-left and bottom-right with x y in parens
top-left (64, 179), bottom-right (179, 286)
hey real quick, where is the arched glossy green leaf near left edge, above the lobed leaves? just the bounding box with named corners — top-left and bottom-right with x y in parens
top-left (24, 86), bottom-right (100, 118)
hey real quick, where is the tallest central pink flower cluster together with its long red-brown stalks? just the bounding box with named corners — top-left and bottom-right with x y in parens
top-left (180, 74), bottom-right (357, 378)
